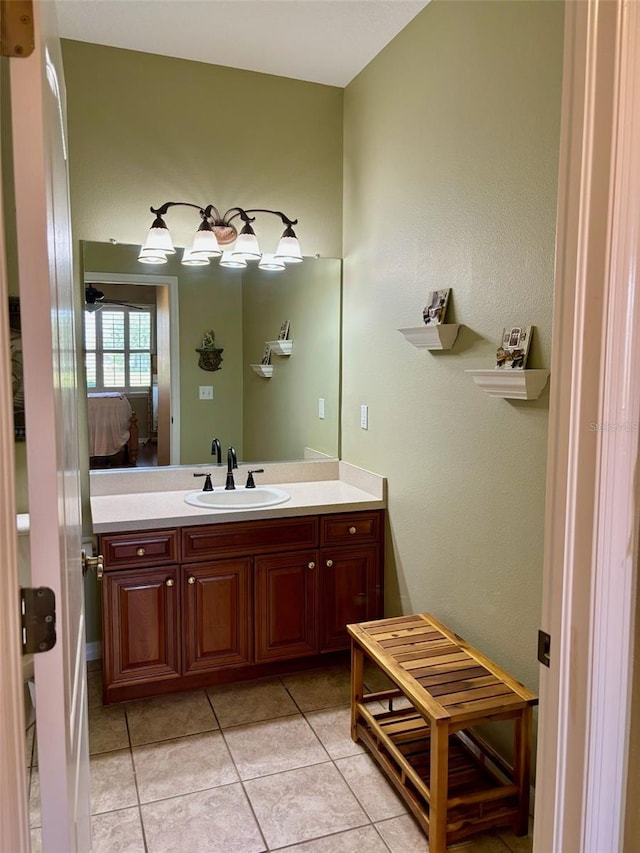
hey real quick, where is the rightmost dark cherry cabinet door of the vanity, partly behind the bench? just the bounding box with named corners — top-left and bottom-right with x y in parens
top-left (320, 547), bottom-right (382, 652)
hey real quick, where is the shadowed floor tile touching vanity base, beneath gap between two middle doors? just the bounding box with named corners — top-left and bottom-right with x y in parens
top-left (207, 678), bottom-right (298, 729)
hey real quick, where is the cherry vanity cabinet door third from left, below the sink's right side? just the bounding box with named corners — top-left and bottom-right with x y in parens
top-left (255, 551), bottom-right (318, 661)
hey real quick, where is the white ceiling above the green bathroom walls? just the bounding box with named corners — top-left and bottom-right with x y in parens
top-left (56, 0), bottom-right (429, 86)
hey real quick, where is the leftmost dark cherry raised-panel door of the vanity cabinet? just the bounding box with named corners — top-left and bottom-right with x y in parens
top-left (102, 566), bottom-right (180, 686)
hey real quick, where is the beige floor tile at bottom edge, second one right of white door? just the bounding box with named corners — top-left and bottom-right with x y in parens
top-left (141, 785), bottom-right (266, 853)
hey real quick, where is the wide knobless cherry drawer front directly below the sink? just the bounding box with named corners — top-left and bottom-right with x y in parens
top-left (182, 515), bottom-right (318, 562)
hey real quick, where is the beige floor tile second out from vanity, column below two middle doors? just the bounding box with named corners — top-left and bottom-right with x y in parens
top-left (224, 714), bottom-right (329, 780)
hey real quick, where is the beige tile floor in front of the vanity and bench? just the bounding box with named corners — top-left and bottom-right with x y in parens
top-left (27, 665), bottom-right (531, 853)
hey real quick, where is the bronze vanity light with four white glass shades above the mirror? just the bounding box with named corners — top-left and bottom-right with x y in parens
top-left (138, 201), bottom-right (302, 271)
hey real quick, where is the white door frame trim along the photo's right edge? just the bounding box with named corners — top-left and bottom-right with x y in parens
top-left (534, 0), bottom-right (640, 853)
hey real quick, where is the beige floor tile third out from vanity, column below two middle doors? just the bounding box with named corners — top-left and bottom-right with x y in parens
top-left (244, 762), bottom-right (369, 849)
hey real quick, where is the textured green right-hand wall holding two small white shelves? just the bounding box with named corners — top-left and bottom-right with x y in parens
top-left (342, 0), bottom-right (563, 700)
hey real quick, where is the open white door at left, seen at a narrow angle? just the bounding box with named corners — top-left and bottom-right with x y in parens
top-left (10, 3), bottom-right (91, 853)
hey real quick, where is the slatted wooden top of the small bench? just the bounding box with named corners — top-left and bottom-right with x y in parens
top-left (348, 613), bottom-right (538, 724)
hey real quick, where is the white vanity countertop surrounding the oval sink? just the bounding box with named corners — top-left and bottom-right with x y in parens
top-left (91, 462), bottom-right (386, 533)
